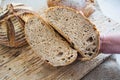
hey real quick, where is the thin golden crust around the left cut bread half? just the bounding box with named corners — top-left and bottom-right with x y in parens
top-left (25, 16), bottom-right (77, 66)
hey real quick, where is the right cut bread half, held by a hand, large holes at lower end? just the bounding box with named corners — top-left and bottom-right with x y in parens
top-left (46, 6), bottom-right (99, 60)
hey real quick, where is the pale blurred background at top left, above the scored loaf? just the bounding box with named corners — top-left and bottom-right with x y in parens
top-left (0, 0), bottom-right (47, 12)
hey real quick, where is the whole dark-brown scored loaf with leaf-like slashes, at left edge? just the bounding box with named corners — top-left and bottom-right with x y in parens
top-left (0, 4), bottom-right (34, 47)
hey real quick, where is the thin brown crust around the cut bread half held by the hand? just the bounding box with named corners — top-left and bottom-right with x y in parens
top-left (46, 6), bottom-right (100, 61)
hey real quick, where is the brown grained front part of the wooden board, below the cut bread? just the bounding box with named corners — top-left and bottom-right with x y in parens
top-left (0, 43), bottom-right (109, 80)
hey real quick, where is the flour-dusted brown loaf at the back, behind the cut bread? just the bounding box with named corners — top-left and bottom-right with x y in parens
top-left (47, 0), bottom-right (95, 17)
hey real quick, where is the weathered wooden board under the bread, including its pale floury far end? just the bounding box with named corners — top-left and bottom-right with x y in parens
top-left (0, 2), bottom-right (120, 80)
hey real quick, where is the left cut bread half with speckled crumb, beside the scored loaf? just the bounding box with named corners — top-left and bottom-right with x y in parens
top-left (25, 17), bottom-right (77, 66)
